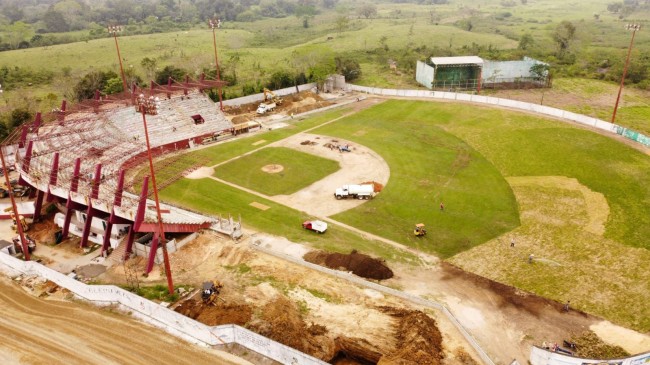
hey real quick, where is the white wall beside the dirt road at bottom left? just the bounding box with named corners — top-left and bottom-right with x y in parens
top-left (0, 253), bottom-right (327, 365)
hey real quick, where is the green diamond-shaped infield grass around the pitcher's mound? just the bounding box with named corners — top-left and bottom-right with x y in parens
top-left (214, 147), bottom-right (340, 196)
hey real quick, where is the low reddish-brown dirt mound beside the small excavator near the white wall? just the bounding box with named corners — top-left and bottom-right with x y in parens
top-left (174, 300), bottom-right (253, 326)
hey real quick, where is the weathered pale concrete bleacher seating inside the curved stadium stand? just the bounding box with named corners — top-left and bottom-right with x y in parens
top-left (23, 91), bottom-right (232, 222)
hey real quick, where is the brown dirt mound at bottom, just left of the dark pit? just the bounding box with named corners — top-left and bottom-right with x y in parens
top-left (244, 297), bottom-right (336, 361)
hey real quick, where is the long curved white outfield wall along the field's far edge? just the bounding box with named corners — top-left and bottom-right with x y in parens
top-left (346, 84), bottom-right (650, 147)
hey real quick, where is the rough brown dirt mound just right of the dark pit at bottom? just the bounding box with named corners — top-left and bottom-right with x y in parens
top-left (377, 307), bottom-right (444, 365)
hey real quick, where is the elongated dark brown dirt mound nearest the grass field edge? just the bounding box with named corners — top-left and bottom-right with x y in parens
top-left (303, 250), bottom-right (393, 280)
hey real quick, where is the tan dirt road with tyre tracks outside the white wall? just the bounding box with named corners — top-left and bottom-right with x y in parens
top-left (0, 276), bottom-right (249, 365)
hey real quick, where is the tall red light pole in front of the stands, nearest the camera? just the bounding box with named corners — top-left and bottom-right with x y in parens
top-left (136, 94), bottom-right (174, 295)
